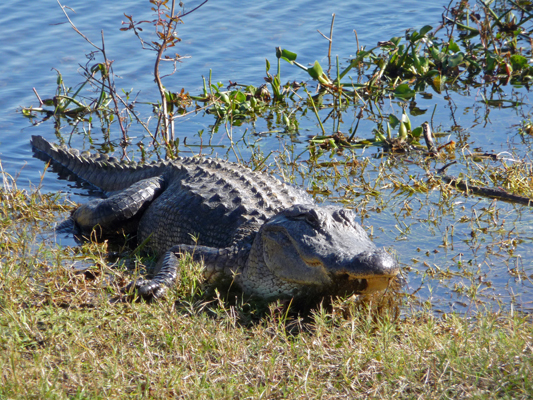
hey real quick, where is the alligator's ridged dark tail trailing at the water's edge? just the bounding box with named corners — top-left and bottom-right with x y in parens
top-left (31, 136), bottom-right (168, 192)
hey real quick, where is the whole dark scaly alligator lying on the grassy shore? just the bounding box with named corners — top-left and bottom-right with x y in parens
top-left (31, 136), bottom-right (399, 301)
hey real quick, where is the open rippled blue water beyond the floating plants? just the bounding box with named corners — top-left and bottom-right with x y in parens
top-left (0, 0), bottom-right (443, 186)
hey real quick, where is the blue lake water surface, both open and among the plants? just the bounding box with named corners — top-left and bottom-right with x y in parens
top-left (0, 0), bottom-right (533, 311)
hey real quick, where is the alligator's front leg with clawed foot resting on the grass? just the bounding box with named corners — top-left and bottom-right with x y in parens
top-left (131, 245), bottom-right (244, 299)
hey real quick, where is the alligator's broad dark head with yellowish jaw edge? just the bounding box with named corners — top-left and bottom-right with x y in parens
top-left (243, 204), bottom-right (399, 297)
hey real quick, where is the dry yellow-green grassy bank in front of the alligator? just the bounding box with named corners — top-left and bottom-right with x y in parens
top-left (0, 182), bottom-right (533, 399)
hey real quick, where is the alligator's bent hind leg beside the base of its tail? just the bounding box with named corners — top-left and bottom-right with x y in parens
top-left (71, 176), bottom-right (165, 233)
